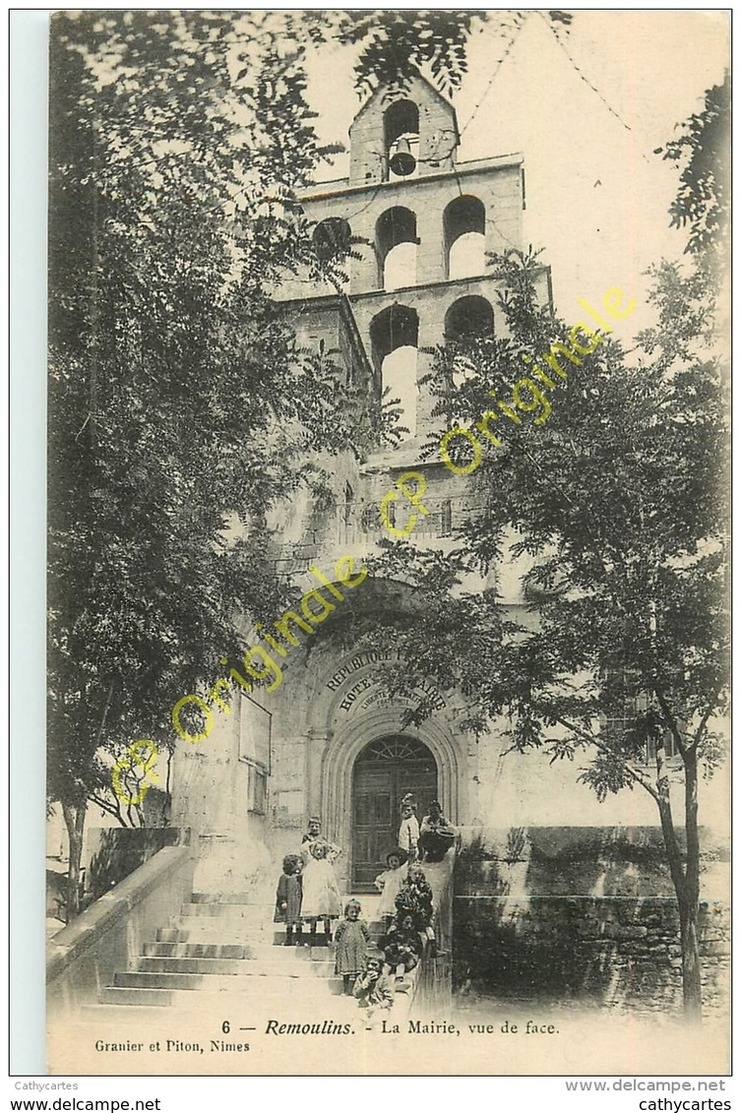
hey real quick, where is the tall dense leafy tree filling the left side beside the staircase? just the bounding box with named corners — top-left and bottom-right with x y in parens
top-left (49, 11), bottom-right (362, 914)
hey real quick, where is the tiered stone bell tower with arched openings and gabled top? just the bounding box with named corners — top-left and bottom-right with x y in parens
top-left (273, 75), bottom-right (550, 509)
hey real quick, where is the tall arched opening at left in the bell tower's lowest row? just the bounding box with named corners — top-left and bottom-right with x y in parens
top-left (371, 305), bottom-right (419, 436)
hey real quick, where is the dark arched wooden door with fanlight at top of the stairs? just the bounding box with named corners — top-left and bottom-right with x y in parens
top-left (352, 735), bottom-right (437, 893)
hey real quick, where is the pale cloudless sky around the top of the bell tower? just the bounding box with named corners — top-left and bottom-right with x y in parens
top-left (308, 10), bottom-right (729, 338)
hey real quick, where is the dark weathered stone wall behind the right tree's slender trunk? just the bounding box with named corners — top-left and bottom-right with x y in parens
top-left (453, 828), bottom-right (730, 1013)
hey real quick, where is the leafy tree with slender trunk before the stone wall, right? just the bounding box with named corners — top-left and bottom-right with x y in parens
top-left (360, 245), bottom-right (728, 1015)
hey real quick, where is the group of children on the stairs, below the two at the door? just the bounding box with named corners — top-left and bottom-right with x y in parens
top-left (274, 816), bottom-right (435, 1012)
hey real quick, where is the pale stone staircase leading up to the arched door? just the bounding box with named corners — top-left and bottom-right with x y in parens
top-left (99, 893), bottom-right (383, 1009)
